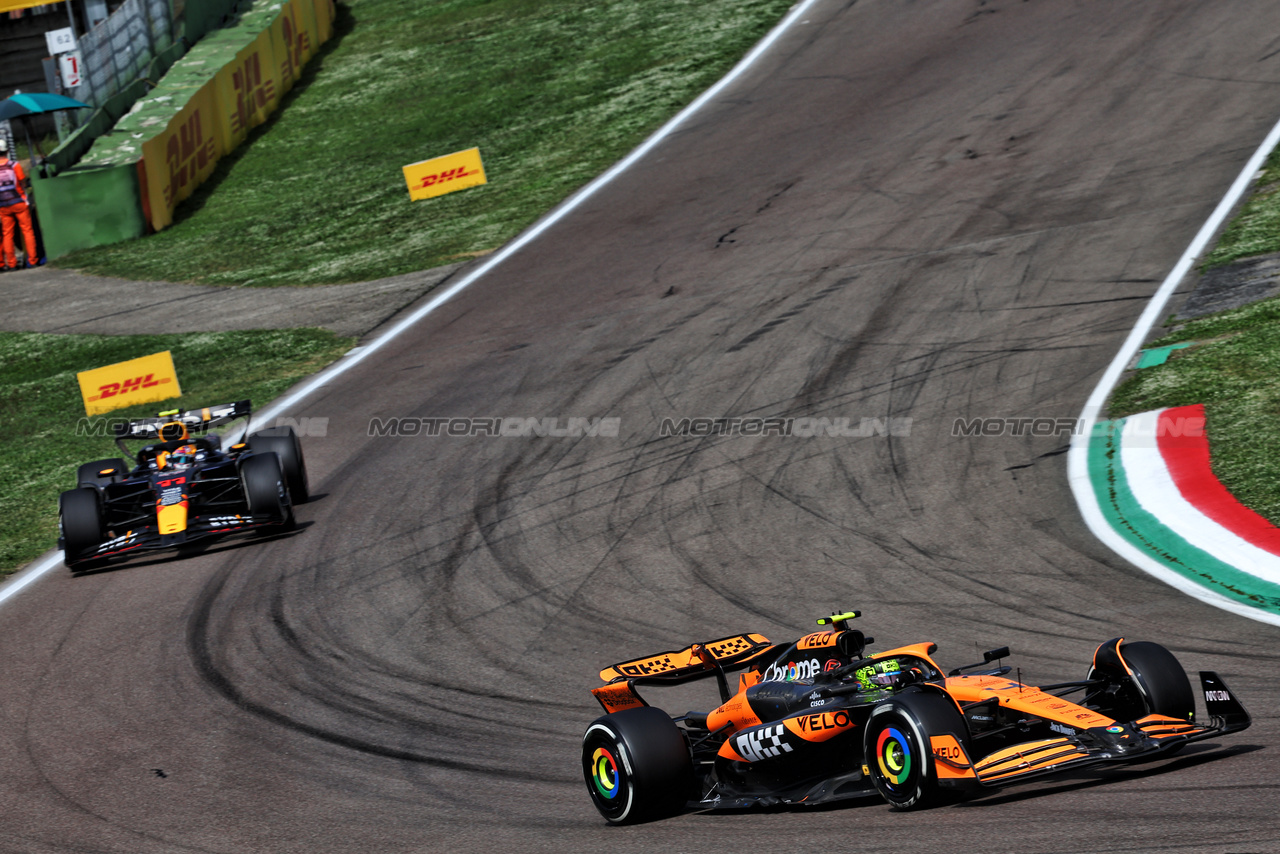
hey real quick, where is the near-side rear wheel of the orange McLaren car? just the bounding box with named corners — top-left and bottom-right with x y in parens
top-left (582, 705), bottom-right (694, 825)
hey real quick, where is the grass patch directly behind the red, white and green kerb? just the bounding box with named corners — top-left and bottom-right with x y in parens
top-left (1110, 298), bottom-right (1280, 524)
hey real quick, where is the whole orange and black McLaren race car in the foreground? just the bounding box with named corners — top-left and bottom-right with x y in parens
top-left (582, 611), bottom-right (1249, 825)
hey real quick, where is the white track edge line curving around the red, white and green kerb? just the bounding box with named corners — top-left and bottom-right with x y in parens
top-left (1066, 112), bottom-right (1280, 625)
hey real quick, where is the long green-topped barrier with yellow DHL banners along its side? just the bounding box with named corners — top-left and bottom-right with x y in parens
top-left (32, 0), bottom-right (335, 259)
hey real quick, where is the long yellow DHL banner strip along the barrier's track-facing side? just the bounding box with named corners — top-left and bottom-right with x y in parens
top-left (138, 0), bottom-right (337, 230)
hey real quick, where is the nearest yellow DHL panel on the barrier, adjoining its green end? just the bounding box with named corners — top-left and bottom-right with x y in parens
top-left (138, 81), bottom-right (227, 230)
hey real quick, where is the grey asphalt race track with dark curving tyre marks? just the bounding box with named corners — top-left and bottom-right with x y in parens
top-left (0, 0), bottom-right (1280, 854)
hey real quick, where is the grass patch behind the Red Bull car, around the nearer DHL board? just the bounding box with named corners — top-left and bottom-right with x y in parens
top-left (0, 329), bottom-right (355, 575)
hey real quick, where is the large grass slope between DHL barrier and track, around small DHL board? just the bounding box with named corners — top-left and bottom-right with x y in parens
top-left (59, 0), bottom-right (791, 286)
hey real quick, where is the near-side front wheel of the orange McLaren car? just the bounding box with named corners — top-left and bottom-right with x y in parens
top-left (863, 691), bottom-right (969, 809)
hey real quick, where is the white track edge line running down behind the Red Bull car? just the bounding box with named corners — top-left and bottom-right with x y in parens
top-left (0, 0), bottom-right (819, 606)
